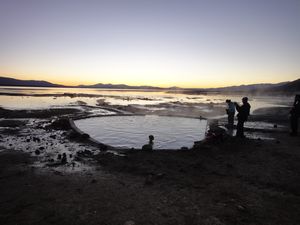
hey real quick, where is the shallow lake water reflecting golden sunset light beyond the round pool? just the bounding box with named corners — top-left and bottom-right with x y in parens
top-left (0, 87), bottom-right (293, 111)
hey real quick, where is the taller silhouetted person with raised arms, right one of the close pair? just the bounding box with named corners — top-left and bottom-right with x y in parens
top-left (234, 97), bottom-right (251, 138)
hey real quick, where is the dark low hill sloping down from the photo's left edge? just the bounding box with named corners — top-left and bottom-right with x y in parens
top-left (0, 77), bottom-right (64, 87)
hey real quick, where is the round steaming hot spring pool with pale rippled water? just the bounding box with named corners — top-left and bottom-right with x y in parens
top-left (75, 115), bottom-right (207, 149)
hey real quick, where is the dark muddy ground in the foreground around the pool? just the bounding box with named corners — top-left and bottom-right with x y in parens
top-left (0, 108), bottom-right (300, 225)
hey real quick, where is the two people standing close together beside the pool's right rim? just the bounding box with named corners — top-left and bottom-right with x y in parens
top-left (226, 97), bottom-right (251, 137)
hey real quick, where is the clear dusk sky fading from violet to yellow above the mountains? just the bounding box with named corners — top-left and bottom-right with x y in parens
top-left (0, 0), bottom-right (300, 88)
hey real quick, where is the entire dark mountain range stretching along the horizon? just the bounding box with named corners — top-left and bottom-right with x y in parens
top-left (0, 77), bottom-right (300, 93)
